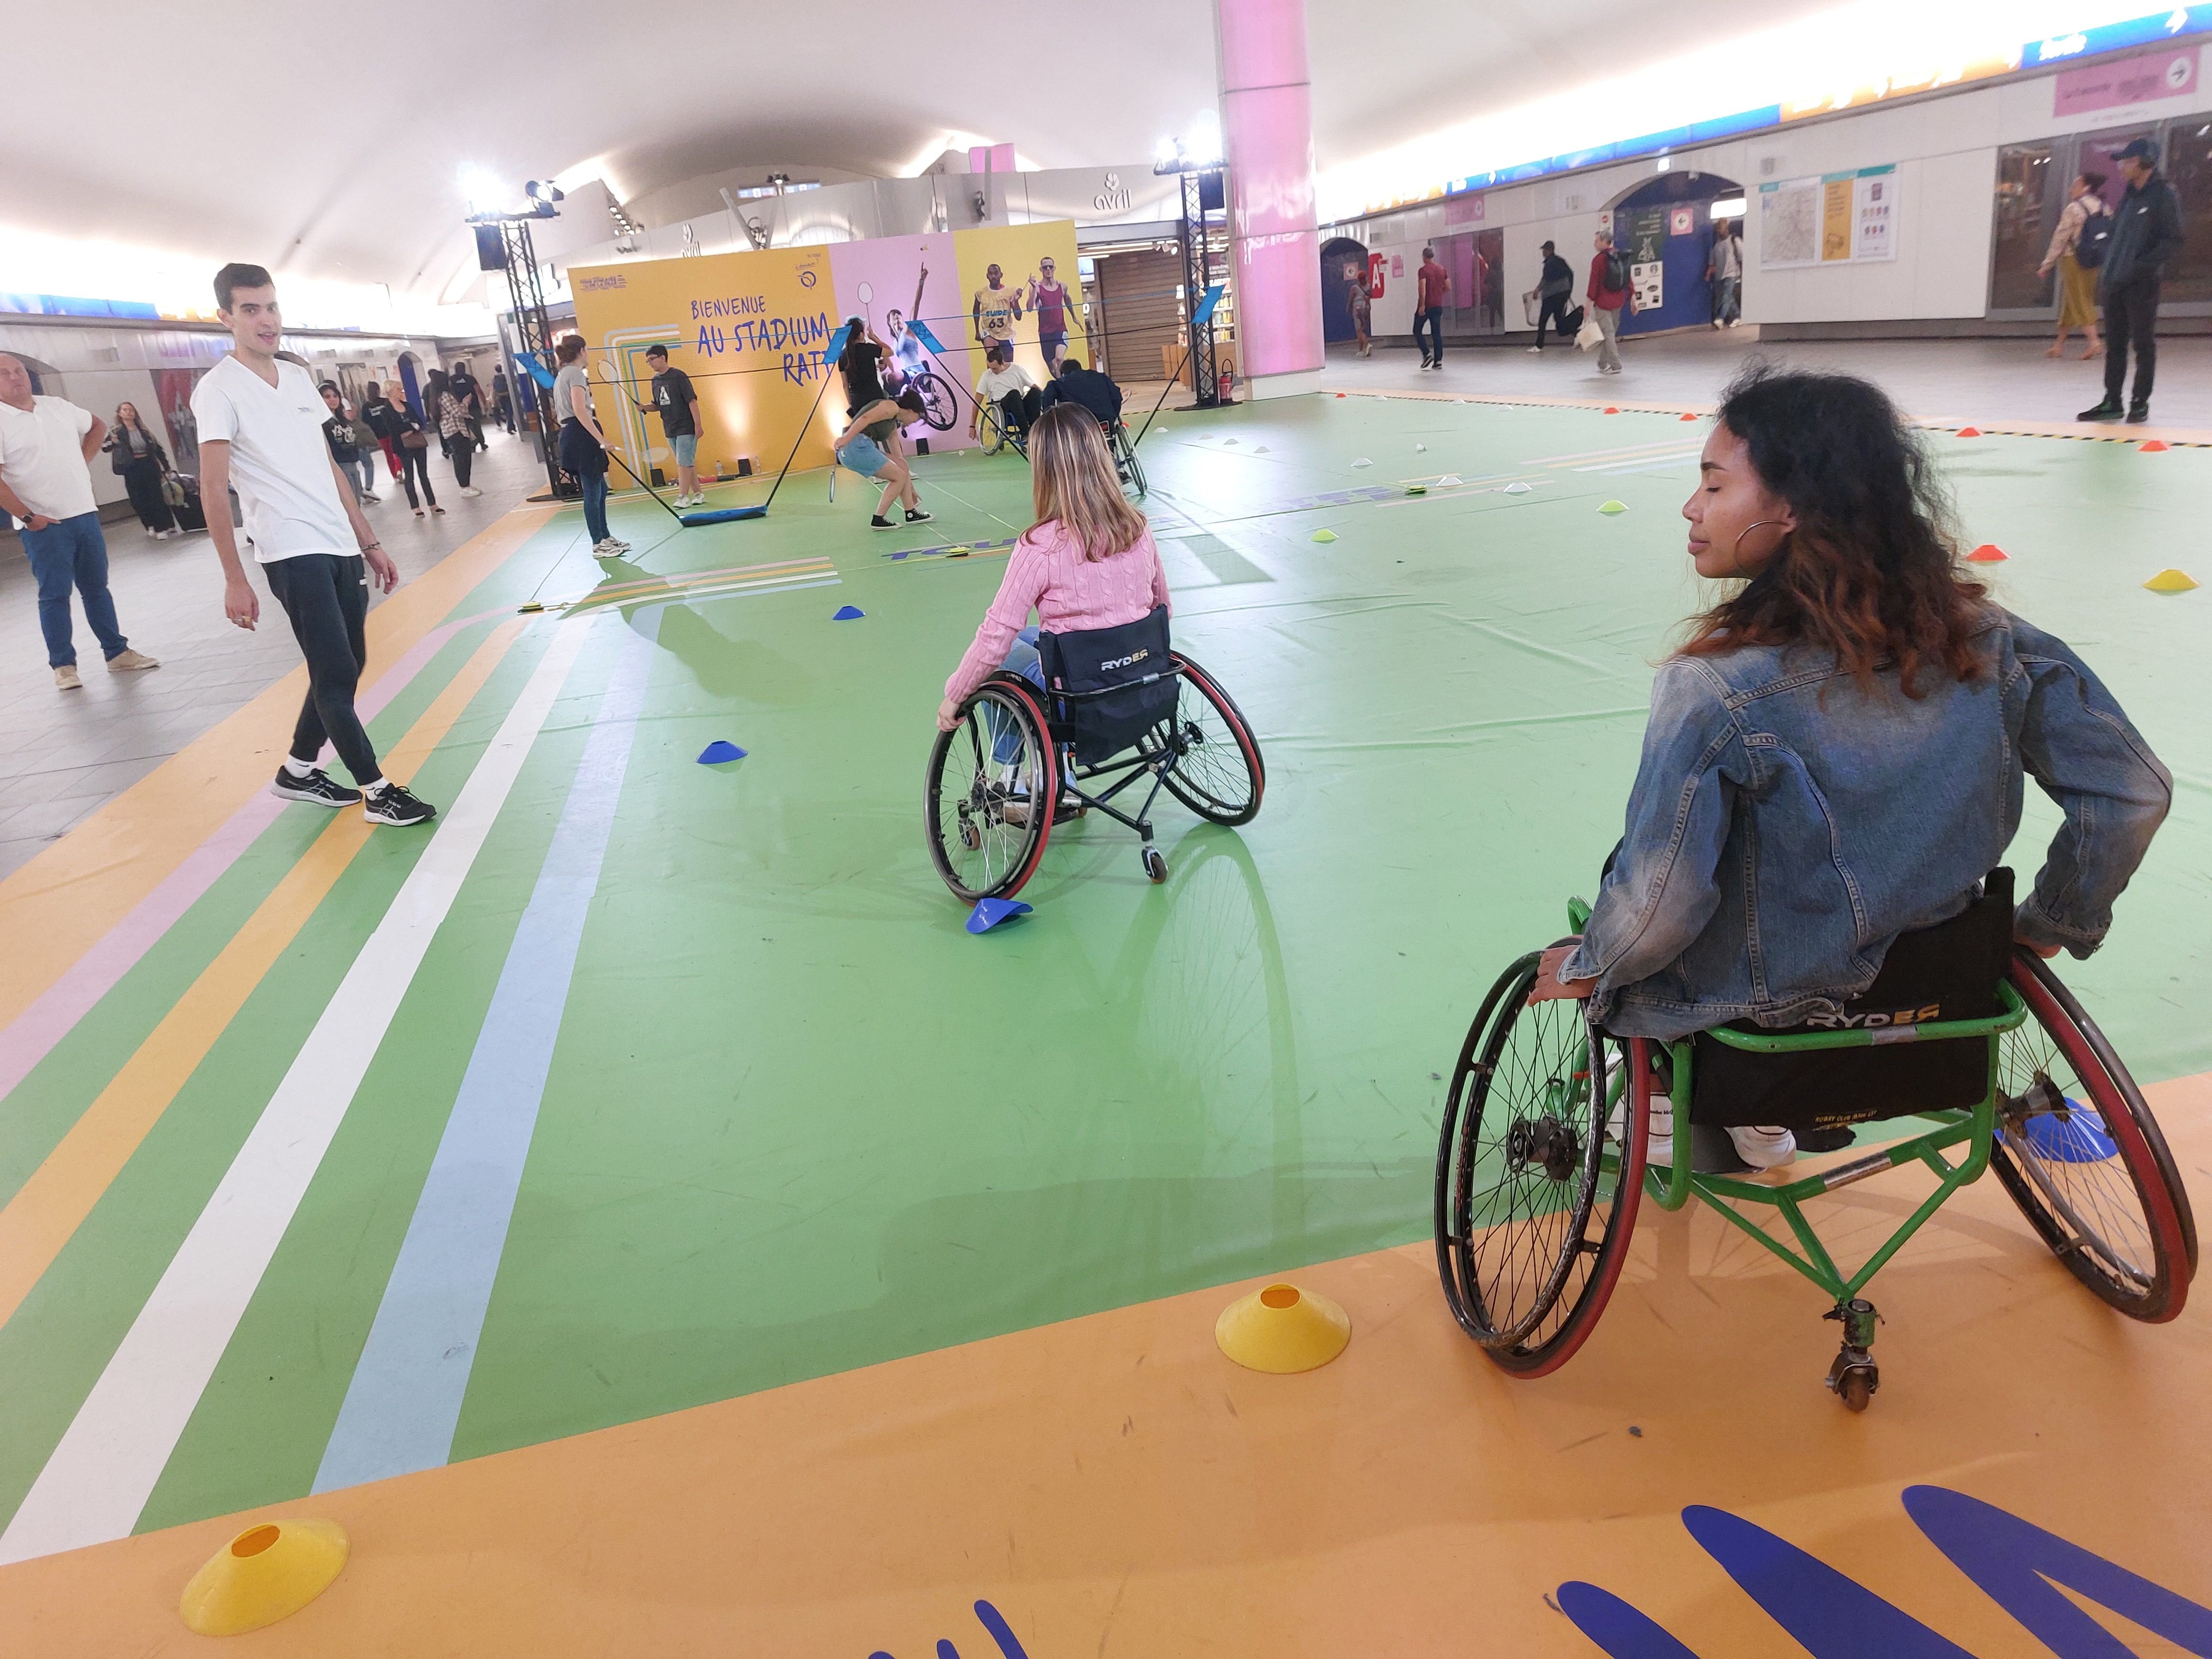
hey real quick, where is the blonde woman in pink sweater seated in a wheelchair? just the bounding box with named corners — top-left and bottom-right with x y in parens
top-left (938, 403), bottom-right (1168, 732)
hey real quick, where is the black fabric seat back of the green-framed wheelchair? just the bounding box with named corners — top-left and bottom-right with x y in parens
top-left (1690, 869), bottom-right (2013, 1128)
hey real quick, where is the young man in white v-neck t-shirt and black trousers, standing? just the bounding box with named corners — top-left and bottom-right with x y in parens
top-left (192, 265), bottom-right (438, 825)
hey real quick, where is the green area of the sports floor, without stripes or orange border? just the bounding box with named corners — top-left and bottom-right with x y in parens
top-left (0, 398), bottom-right (2212, 1528)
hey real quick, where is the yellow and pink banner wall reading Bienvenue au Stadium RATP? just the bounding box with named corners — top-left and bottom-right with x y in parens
top-left (568, 219), bottom-right (1091, 476)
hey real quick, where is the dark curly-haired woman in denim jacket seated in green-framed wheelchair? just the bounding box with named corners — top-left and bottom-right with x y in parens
top-left (1528, 367), bottom-right (2172, 1168)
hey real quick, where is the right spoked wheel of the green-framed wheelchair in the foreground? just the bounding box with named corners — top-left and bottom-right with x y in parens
top-left (1991, 951), bottom-right (2197, 1325)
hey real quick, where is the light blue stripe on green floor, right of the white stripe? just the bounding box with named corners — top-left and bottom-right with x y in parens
top-left (314, 613), bottom-right (659, 1491)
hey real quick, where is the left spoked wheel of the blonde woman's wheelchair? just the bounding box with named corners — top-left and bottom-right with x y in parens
top-left (929, 675), bottom-right (1060, 903)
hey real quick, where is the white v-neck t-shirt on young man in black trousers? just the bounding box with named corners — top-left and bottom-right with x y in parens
top-left (192, 356), bottom-right (361, 564)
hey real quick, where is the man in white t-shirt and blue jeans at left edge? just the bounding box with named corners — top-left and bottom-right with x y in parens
top-left (0, 352), bottom-right (162, 690)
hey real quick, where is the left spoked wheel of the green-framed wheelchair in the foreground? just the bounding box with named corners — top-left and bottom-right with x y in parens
top-left (1436, 951), bottom-right (1648, 1378)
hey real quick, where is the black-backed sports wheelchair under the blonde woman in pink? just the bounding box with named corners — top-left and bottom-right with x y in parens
top-left (927, 608), bottom-right (1268, 903)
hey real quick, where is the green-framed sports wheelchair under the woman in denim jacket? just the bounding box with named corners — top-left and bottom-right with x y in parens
top-left (1436, 869), bottom-right (2197, 1411)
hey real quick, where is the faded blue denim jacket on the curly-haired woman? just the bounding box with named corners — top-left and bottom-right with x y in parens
top-left (1562, 606), bottom-right (2172, 1038)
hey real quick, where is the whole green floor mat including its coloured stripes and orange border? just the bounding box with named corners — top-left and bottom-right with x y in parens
top-left (0, 385), bottom-right (2212, 1659)
